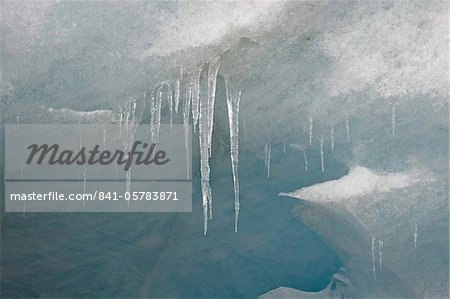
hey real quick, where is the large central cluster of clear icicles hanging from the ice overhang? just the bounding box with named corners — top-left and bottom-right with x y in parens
top-left (118, 56), bottom-right (241, 235)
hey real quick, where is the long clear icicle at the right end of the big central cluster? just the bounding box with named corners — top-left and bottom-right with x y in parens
top-left (227, 88), bottom-right (241, 232)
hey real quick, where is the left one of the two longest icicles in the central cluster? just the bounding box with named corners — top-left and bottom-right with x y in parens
top-left (200, 72), bottom-right (212, 235)
